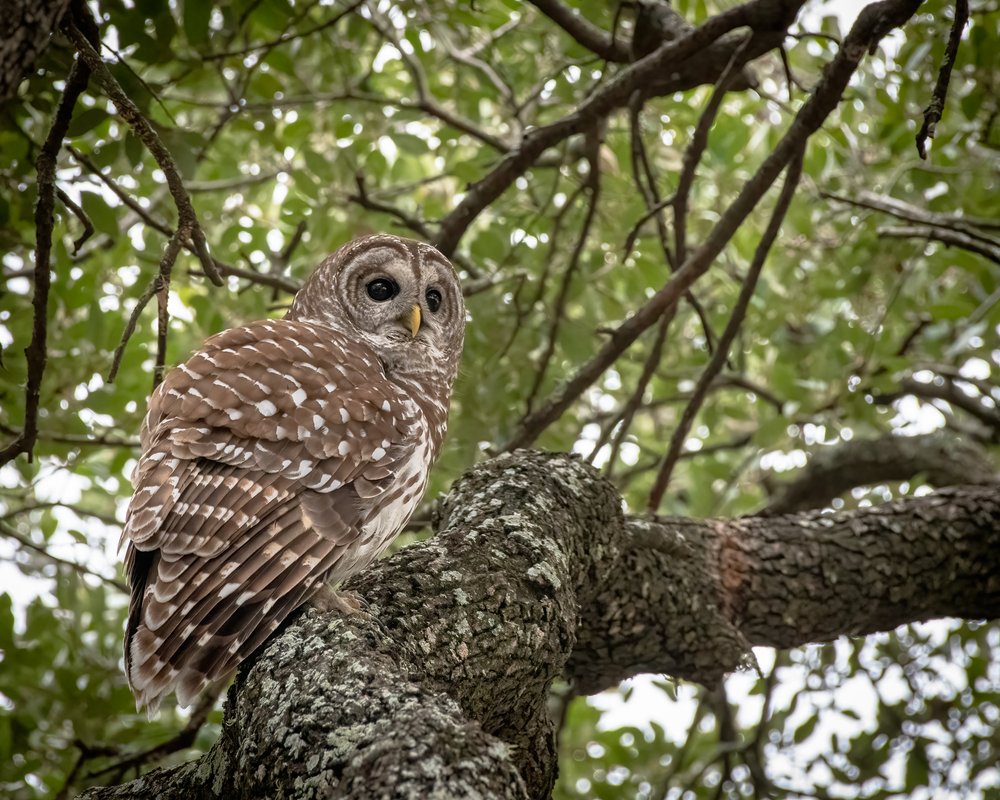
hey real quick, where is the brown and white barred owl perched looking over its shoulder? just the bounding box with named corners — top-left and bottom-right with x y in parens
top-left (122, 235), bottom-right (465, 714)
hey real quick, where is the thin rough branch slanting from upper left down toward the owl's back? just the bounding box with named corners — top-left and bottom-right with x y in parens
top-left (67, 25), bottom-right (223, 286)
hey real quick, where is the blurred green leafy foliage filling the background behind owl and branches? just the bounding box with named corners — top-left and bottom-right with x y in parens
top-left (0, 0), bottom-right (1000, 798)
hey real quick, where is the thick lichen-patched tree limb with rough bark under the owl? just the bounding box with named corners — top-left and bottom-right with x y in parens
top-left (80, 451), bottom-right (1000, 800)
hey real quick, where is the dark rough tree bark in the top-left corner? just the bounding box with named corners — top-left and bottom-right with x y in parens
top-left (0, 0), bottom-right (70, 104)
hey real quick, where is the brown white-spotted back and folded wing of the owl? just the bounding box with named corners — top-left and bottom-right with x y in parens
top-left (122, 320), bottom-right (418, 709)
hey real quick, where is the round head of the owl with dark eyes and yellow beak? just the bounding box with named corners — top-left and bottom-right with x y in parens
top-left (288, 233), bottom-right (465, 379)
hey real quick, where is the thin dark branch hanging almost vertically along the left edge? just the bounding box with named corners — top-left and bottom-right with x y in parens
top-left (0, 48), bottom-right (90, 466)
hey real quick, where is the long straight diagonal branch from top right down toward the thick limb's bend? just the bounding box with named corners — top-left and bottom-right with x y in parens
top-left (500, 0), bottom-right (920, 449)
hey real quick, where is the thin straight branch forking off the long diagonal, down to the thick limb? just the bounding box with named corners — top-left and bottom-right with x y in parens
top-left (647, 147), bottom-right (805, 513)
